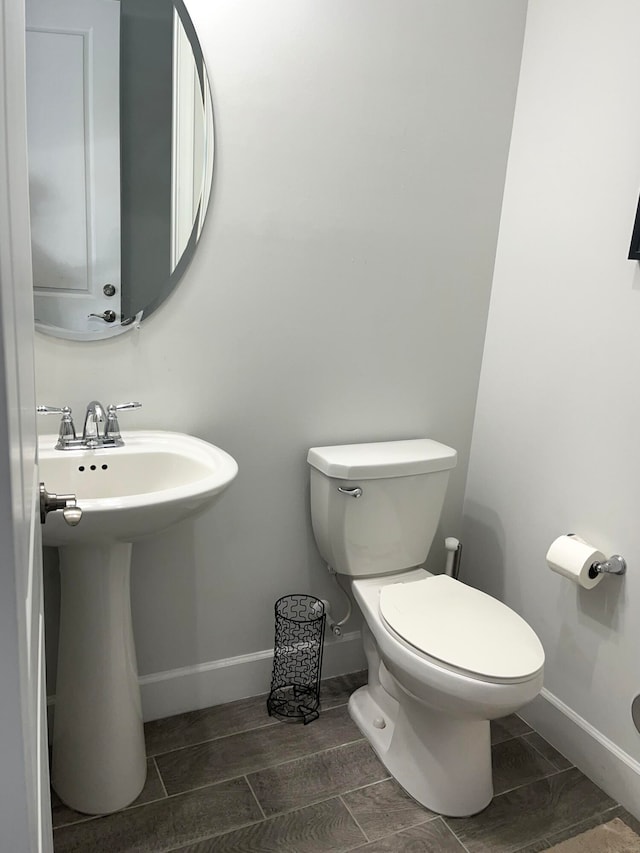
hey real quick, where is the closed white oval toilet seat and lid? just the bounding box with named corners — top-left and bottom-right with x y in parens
top-left (379, 575), bottom-right (544, 682)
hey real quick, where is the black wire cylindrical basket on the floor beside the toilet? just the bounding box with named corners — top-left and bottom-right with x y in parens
top-left (267, 595), bottom-right (325, 725)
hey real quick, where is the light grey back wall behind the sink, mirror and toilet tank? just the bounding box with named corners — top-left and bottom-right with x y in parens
top-left (37, 0), bottom-right (525, 712)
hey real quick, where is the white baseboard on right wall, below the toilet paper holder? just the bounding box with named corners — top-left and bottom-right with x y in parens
top-left (519, 688), bottom-right (640, 820)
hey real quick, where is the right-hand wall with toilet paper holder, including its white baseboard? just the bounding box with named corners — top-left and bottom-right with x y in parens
top-left (464, 0), bottom-right (640, 813)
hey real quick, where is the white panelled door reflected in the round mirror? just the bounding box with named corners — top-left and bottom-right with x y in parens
top-left (26, 0), bottom-right (120, 329)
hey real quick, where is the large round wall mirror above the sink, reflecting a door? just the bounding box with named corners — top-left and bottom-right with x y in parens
top-left (26, 0), bottom-right (213, 340)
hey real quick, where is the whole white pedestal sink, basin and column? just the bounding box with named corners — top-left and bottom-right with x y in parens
top-left (39, 431), bottom-right (238, 814)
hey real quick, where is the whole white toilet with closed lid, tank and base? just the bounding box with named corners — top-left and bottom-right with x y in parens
top-left (307, 439), bottom-right (544, 817)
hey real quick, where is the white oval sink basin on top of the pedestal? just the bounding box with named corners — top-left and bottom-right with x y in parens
top-left (39, 430), bottom-right (238, 545)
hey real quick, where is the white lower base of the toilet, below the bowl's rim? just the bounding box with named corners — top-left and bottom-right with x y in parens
top-left (349, 683), bottom-right (493, 817)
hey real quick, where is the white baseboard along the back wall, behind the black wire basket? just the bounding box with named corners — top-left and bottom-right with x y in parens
top-left (139, 631), bottom-right (366, 721)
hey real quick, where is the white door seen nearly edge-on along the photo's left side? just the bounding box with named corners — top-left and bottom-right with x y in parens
top-left (0, 0), bottom-right (53, 853)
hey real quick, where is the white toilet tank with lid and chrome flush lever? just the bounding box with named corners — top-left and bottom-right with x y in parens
top-left (307, 438), bottom-right (457, 577)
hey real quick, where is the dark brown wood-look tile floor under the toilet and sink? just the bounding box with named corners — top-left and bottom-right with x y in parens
top-left (53, 673), bottom-right (640, 853)
